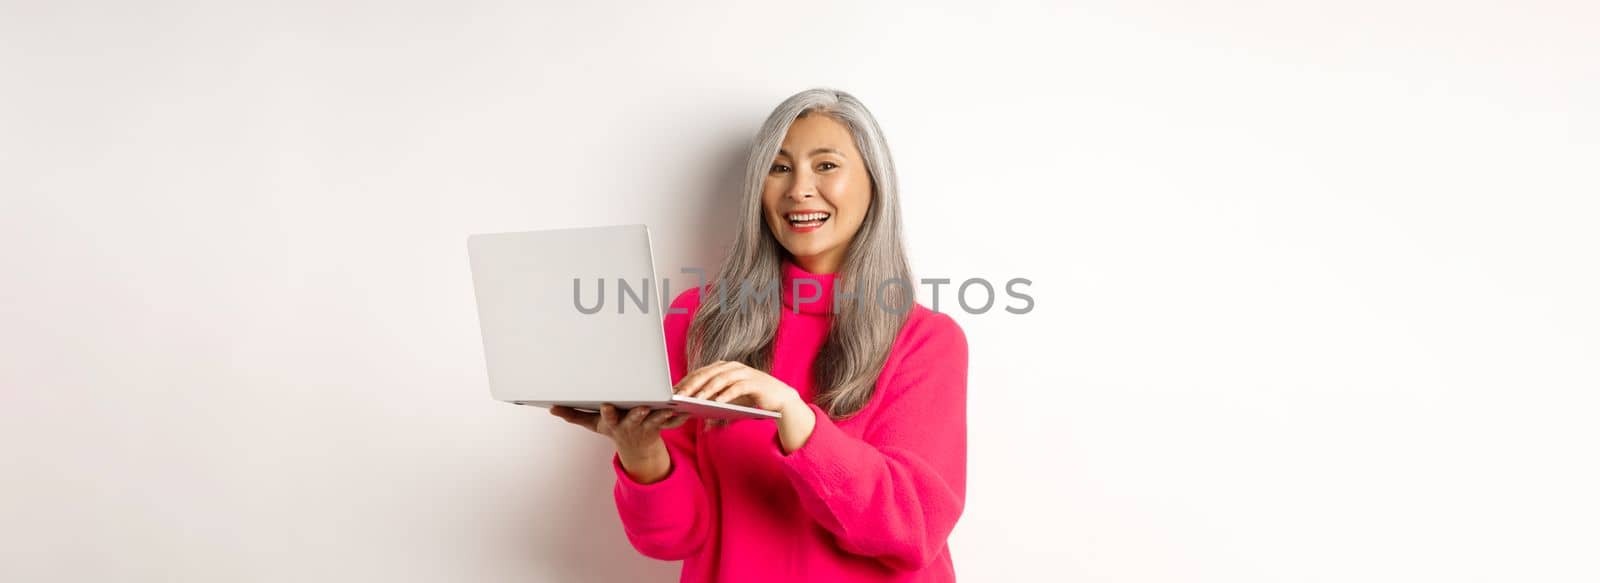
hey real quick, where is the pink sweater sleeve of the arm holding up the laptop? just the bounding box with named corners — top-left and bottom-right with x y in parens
top-left (611, 288), bottom-right (710, 561)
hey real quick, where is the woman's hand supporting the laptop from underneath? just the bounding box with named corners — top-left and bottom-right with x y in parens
top-left (550, 404), bottom-right (690, 484)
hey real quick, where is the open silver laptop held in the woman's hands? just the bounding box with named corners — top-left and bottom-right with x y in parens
top-left (467, 224), bottom-right (779, 420)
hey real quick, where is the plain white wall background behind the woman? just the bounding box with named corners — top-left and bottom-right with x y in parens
top-left (0, 0), bottom-right (1600, 583)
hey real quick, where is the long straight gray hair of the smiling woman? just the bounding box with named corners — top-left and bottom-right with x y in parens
top-left (688, 88), bottom-right (915, 418)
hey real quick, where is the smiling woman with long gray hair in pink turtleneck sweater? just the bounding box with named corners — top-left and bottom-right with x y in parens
top-left (552, 90), bottom-right (966, 581)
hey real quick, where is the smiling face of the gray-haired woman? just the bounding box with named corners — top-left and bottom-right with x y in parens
top-left (762, 112), bottom-right (872, 274)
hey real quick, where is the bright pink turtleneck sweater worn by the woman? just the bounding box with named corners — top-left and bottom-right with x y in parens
top-left (611, 261), bottom-right (966, 581)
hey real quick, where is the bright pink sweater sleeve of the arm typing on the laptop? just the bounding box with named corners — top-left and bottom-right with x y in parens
top-left (773, 312), bottom-right (966, 570)
